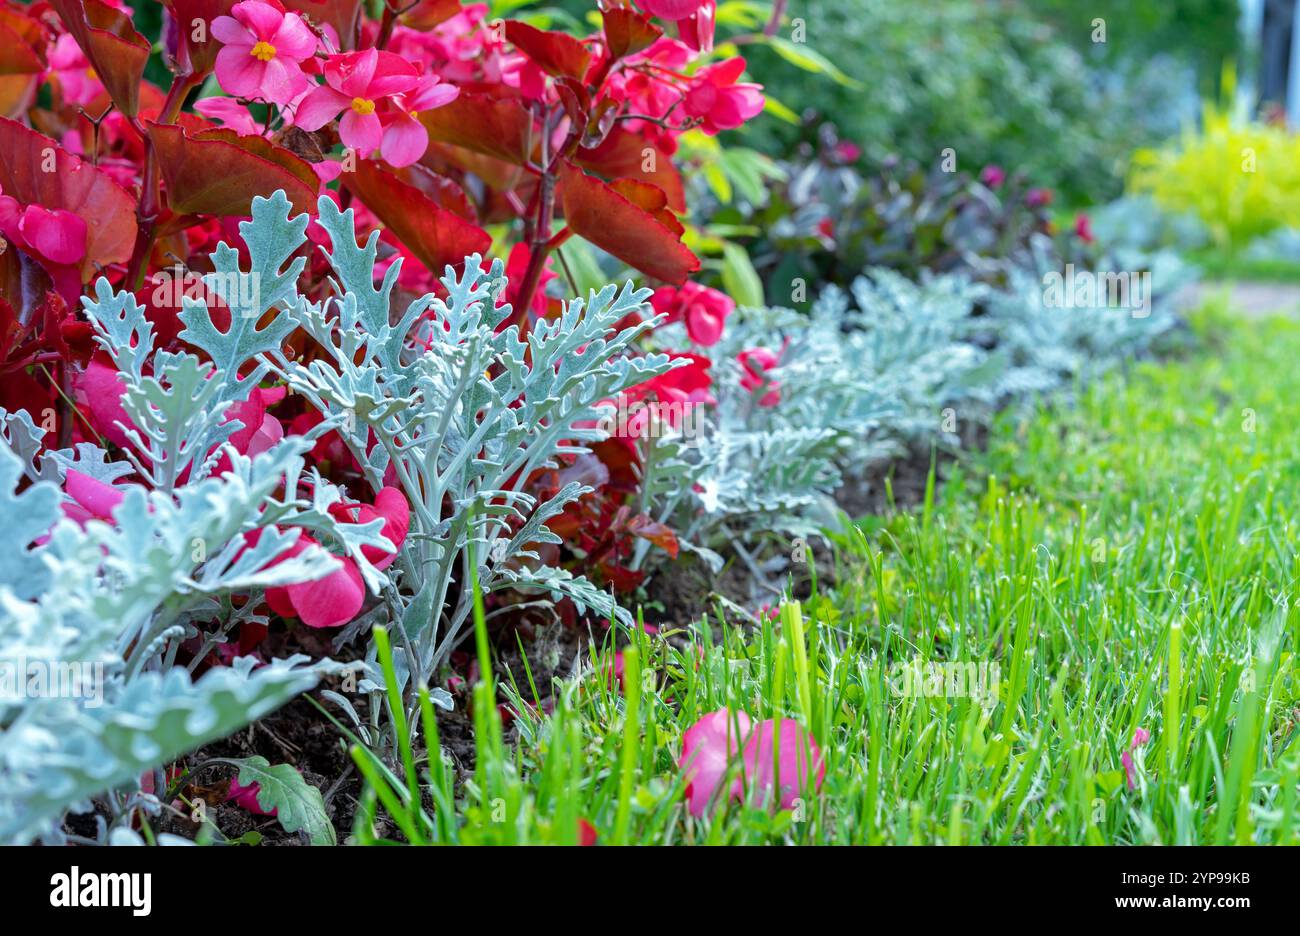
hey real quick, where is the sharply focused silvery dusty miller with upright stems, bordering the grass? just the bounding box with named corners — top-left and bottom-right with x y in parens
top-left (235, 189), bottom-right (672, 723)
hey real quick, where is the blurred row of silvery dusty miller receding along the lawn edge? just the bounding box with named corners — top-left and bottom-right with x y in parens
top-left (636, 251), bottom-right (1187, 592)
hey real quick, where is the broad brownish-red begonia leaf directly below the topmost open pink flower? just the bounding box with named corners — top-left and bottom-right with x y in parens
top-left (146, 122), bottom-right (320, 217)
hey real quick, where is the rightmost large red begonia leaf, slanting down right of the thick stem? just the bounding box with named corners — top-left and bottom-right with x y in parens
top-left (560, 163), bottom-right (699, 285)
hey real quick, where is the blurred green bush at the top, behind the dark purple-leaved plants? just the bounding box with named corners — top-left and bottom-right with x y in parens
top-left (743, 0), bottom-right (1239, 204)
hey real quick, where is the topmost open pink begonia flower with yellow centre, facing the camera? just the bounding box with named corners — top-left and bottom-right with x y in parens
top-left (212, 0), bottom-right (316, 104)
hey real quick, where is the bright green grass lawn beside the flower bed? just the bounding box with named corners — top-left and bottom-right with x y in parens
top-left (354, 302), bottom-right (1300, 844)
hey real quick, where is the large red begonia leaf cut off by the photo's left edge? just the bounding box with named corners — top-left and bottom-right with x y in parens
top-left (0, 117), bottom-right (135, 280)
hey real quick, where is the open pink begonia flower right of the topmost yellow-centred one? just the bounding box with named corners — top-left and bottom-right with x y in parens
top-left (294, 48), bottom-right (420, 156)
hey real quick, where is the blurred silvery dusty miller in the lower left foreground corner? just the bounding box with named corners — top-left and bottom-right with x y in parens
top-left (0, 412), bottom-right (356, 842)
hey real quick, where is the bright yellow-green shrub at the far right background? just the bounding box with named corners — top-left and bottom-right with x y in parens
top-left (1130, 104), bottom-right (1300, 250)
